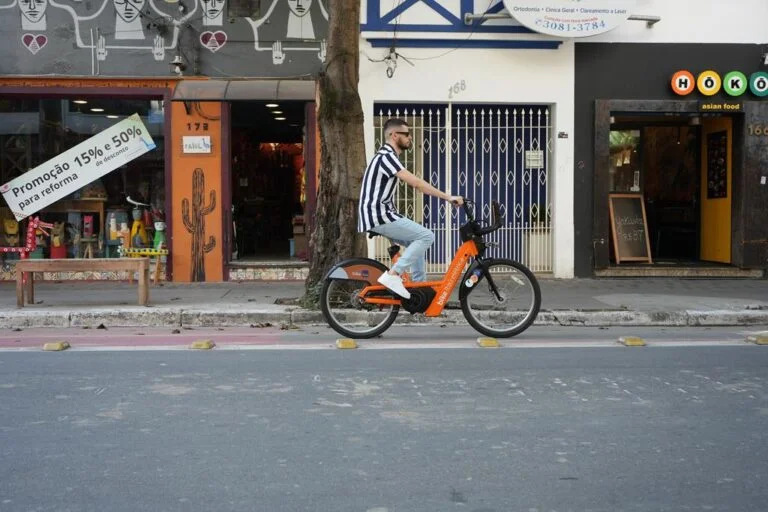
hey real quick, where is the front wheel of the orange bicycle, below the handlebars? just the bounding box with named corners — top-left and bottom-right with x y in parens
top-left (459, 258), bottom-right (541, 338)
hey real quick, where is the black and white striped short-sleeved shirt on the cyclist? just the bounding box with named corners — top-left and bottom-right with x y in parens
top-left (357, 144), bottom-right (405, 233)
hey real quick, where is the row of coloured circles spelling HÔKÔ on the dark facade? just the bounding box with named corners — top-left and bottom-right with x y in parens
top-left (672, 69), bottom-right (768, 98)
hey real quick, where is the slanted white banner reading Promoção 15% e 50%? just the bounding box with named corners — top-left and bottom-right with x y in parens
top-left (0, 114), bottom-right (155, 220)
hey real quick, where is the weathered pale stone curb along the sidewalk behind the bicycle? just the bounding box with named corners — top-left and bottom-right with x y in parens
top-left (0, 304), bottom-right (768, 329)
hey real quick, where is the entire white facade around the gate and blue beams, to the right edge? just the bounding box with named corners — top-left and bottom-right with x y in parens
top-left (360, 0), bottom-right (768, 278)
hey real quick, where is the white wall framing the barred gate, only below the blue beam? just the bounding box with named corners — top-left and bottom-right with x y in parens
top-left (359, 41), bottom-right (574, 277)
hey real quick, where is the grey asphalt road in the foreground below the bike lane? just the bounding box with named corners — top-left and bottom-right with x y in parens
top-left (0, 343), bottom-right (768, 512)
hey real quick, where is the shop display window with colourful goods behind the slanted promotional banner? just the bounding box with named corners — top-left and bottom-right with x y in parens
top-left (0, 95), bottom-right (166, 258)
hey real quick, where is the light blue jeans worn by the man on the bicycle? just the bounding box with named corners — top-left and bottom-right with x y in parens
top-left (371, 217), bottom-right (435, 281)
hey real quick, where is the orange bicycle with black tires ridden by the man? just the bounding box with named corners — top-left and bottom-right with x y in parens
top-left (320, 199), bottom-right (541, 338)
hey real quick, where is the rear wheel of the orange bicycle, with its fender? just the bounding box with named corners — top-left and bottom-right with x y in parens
top-left (320, 258), bottom-right (400, 339)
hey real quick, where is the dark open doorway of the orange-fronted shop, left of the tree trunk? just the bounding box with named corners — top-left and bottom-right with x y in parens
top-left (230, 100), bottom-right (307, 262)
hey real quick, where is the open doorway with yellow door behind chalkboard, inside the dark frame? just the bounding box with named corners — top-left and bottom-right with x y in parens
top-left (608, 112), bottom-right (733, 266)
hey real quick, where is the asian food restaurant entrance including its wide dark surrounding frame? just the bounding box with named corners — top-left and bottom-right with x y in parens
top-left (593, 100), bottom-right (761, 277)
